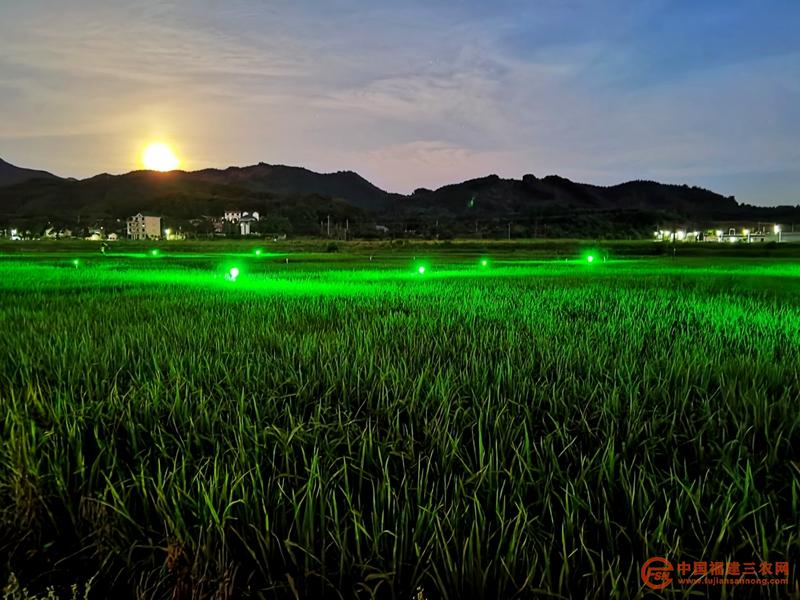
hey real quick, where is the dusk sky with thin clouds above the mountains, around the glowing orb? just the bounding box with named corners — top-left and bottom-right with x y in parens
top-left (0, 0), bottom-right (800, 205)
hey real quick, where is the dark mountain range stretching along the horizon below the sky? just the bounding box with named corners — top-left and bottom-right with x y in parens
top-left (0, 160), bottom-right (800, 236)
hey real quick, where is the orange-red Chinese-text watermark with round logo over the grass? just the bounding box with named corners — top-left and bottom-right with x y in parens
top-left (641, 556), bottom-right (789, 590)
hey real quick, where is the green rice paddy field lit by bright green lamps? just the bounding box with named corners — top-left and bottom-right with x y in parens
top-left (0, 243), bottom-right (800, 600)
